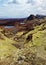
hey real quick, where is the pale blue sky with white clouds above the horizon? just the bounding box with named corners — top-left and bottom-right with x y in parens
top-left (0, 0), bottom-right (46, 18)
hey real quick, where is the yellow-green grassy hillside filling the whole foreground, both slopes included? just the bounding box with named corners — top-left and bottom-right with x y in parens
top-left (0, 19), bottom-right (46, 65)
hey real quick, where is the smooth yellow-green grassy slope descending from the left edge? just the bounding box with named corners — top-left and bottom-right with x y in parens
top-left (0, 32), bottom-right (19, 65)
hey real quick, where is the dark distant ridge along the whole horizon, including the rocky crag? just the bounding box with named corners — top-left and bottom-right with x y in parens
top-left (0, 15), bottom-right (46, 26)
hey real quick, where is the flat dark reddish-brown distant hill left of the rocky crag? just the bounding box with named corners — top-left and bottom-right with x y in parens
top-left (0, 18), bottom-right (26, 26)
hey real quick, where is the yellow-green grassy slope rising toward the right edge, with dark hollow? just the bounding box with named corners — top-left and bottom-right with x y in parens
top-left (13, 21), bottom-right (46, 65)
